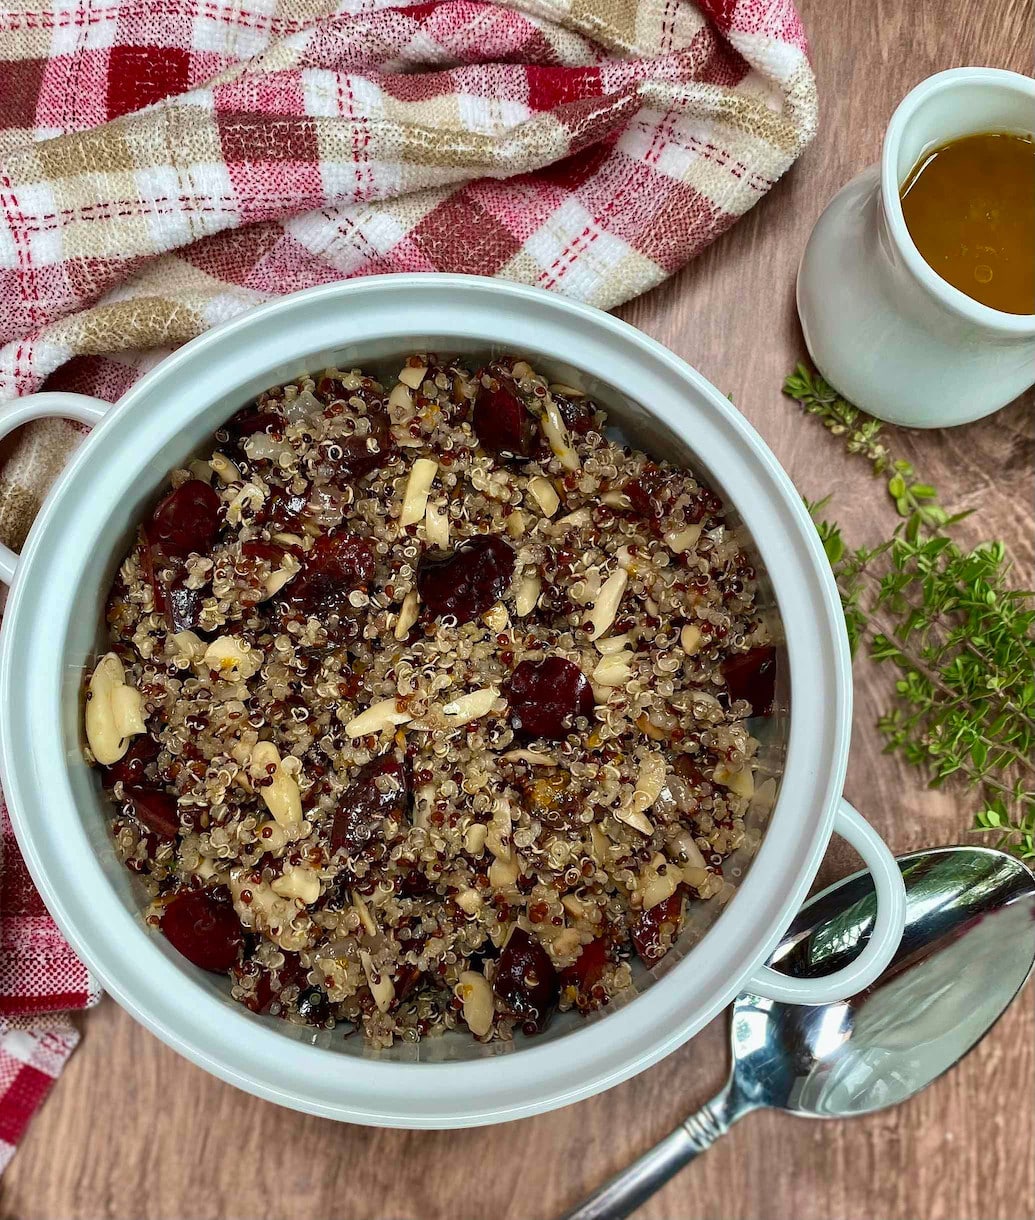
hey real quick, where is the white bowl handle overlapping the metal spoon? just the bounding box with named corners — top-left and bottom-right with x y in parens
top-left (743, 799), bottom-right (906, 1004)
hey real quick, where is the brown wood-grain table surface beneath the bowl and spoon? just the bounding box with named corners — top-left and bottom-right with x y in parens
top-left (0, 0), bottom-right (1035, 1220)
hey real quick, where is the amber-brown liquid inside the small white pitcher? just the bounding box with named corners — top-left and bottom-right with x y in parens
top-left (902, 132), bottom-right (1035, 314)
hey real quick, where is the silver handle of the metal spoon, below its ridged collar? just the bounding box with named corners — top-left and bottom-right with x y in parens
top-left (561, 1089), bottom-right (740, 1220)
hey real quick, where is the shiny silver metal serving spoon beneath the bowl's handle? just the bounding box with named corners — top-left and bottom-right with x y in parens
top-left (564, 847), bottom-right (1035, 1220)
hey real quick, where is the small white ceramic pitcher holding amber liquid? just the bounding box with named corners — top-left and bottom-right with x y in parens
top-left (798, 68), bottom-right (1035, 428)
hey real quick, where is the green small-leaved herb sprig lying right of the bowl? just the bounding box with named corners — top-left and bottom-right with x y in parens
top-left (784, 365), bottom-right (1035, 860)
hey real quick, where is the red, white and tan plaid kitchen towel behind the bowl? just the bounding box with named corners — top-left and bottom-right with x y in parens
top-left (0, 0), bottom-right (817, 1160)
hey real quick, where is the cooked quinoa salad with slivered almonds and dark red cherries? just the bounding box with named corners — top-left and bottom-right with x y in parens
top-left (84, 354), bottom-right (775, 1047)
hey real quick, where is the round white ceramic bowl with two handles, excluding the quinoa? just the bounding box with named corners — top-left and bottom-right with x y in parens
top-left (0, 276), bottom-right (904, 1127)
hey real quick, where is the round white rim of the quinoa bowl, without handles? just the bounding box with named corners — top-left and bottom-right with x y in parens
top-left (0, 273), bottom-right (851, 1129)
